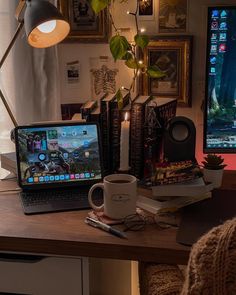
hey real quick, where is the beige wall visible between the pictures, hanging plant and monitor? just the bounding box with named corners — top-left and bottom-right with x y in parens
top-left (59, 0), bottom-right (236, 169)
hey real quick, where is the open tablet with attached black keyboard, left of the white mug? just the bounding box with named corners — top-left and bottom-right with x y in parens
top-left (15, 122), bottom-right (103, 214)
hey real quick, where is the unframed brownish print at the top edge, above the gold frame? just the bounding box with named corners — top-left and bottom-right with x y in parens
top-left (159, 0), bottom-right (188, 33)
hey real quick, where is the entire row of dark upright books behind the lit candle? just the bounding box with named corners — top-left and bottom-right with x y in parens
top-left (81, 95), bottom-right (177, 179)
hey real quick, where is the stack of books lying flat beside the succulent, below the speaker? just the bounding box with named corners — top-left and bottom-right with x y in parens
top-left (138, 161), bottom-right (213, 214)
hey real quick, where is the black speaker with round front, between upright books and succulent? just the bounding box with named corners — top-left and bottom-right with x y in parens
top-left (163, 116), bottom-right (196, 162)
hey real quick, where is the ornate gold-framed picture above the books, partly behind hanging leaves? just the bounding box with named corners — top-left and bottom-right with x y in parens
top-left (139, 36), bottom-right (192, 106)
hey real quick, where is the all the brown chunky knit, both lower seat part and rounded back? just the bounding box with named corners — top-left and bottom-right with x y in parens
top-left (139, 218), bottom-right (236, 295)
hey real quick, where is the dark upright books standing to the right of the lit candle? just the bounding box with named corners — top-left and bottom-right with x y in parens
top-left (130, 96), bottom-right (177, 179)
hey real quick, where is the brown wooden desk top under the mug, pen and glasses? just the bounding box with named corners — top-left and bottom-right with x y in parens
top-left (0, 173), bottom-right (236, 264)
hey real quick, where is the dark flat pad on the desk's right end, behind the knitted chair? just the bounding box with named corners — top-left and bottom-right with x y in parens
top-left (176, 189), bottom-right (236, 246)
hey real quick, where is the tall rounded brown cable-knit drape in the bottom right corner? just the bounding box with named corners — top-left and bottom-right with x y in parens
top-left (181, 219), bottom-right (236, 295)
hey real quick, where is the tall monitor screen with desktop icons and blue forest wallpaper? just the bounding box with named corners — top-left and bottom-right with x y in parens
top-left (204, 6), bottom-right (236, 153)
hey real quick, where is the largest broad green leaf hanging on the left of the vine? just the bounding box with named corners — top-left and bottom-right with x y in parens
top-left (110, 35), bottom-right (130, 61)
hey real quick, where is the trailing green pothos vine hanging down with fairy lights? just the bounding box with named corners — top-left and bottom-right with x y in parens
top-left (91, 0), bottom-right (165, 107)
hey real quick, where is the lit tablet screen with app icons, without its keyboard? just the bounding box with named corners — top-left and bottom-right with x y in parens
top-left (15, 123), bottom-right (102, 188)
